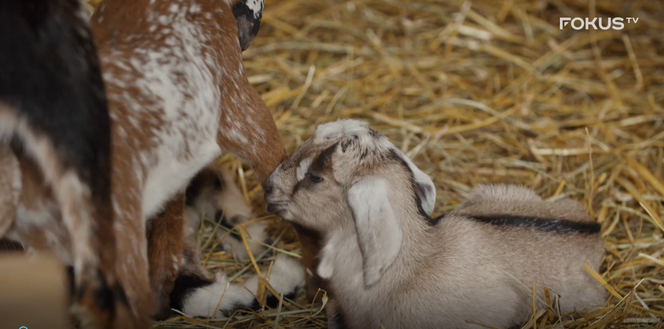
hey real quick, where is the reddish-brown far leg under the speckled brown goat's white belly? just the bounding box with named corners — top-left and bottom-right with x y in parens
top-left (148, 193), bottom-right (185, 319)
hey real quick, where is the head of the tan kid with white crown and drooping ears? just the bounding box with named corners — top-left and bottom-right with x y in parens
top-left (264, 120), bottom-right (436, 286)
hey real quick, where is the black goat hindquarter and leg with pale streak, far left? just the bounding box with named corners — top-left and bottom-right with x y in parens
top-left (0, 0), bottom-right (124, 328)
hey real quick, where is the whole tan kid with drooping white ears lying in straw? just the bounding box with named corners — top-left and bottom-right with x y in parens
top-left (264, 120), bottom-right (605, 329)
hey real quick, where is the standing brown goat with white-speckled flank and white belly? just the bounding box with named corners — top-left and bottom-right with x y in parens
top-left (91, 0), bottom-right (316, 322)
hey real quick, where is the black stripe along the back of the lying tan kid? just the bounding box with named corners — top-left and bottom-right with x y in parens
top-left (468, 215), bottom-right (600, 235)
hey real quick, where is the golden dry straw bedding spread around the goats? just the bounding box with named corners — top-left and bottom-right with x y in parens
top-left (88, 0), bottom-right (664, 328)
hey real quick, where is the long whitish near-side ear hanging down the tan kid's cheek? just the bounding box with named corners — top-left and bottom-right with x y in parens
top-left (348, 178), bottom-right (403, 287)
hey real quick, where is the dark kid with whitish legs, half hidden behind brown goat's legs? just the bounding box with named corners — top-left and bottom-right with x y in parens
top-left (175, 165), bottom-right (304, 317)
